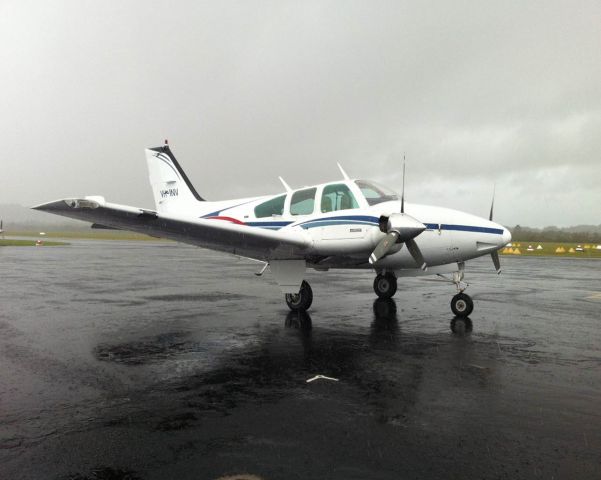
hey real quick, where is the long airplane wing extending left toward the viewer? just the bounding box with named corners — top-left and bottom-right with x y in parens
top-left (33, 197), bottom-right (311, 261)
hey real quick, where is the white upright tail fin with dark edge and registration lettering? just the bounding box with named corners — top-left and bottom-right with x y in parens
top-left (146, 143), bottom-right (205, 212)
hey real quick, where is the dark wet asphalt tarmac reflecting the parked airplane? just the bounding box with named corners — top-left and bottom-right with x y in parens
top-left (0, 241), bottom-right (601, 480)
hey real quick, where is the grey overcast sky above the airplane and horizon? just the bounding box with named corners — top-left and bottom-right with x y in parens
top-left (0, 0), bottom-right (601, 226)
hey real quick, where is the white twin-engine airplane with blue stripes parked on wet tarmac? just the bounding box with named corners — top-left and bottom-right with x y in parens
top-left (33, 141), bottom-right (511, 317)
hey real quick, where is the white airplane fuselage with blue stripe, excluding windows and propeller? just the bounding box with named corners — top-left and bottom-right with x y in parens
top-left (166, 180), bottom-right (511, 275)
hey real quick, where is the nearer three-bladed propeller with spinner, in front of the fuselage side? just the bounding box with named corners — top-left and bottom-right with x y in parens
top-left (369, 158), bottom-right (427, 270)
